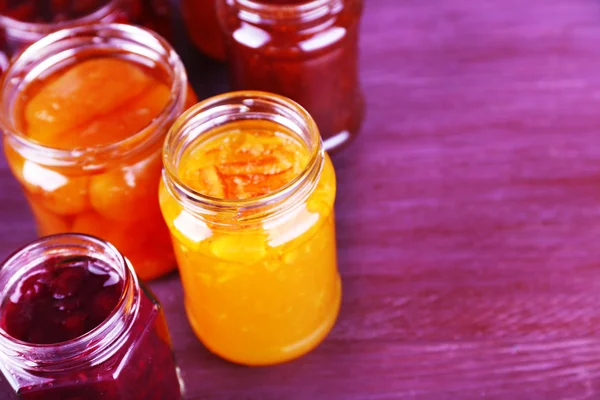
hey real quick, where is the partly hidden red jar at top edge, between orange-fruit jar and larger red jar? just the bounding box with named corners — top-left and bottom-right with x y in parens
top-left (181, 0), bottom-right (226, 61)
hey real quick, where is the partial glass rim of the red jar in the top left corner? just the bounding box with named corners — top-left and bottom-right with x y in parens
top-left (0, 0), bottom-right (121, 33)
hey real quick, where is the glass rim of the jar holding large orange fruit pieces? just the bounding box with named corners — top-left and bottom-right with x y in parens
top-left (0, 23), bottom-right (188, 170)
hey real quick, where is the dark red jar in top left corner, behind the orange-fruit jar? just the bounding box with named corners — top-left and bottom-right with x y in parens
top-left (0, 0), bottom-right (172, 69)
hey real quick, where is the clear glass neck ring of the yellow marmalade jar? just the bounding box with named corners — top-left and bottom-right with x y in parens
top-left (163, 91), bottom-right (325, 227)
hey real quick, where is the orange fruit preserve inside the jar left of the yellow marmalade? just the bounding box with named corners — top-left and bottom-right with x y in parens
top-left (5, 57), bottom-right (195, 279)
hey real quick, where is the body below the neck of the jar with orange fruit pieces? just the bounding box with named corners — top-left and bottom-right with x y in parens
top-left (4, 142), bottom-right (175, 280)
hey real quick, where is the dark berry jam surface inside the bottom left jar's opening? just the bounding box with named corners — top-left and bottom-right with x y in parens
top-left (0, 257), bottom-right (123, 344)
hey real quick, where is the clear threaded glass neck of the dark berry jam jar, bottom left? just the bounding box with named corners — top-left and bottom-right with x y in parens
top-left (0, 234), bottom-right (140, 372)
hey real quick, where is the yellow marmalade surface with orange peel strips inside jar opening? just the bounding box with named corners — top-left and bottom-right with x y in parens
top-left (179, 121), bottom-right (309, 200)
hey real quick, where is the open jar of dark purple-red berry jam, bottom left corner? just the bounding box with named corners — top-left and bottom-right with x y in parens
top-left (0, 234), bottom-right (182, 400)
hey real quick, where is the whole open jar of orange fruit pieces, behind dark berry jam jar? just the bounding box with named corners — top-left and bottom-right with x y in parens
top-left (0, 24), bottom-right (196, 279)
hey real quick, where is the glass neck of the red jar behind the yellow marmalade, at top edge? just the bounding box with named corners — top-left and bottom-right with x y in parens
top-left (225, 0), bottom-right (346, 26)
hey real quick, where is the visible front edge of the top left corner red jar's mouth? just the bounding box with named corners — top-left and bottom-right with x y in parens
top-left (0, 0), bottom-right (121, 34)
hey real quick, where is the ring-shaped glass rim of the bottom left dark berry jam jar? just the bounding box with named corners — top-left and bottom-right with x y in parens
top-left (0, 233), bottom-right (140, 371)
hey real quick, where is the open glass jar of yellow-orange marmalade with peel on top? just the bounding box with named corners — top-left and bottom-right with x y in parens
top-left (159, 92), bottom-right (341, 365)
